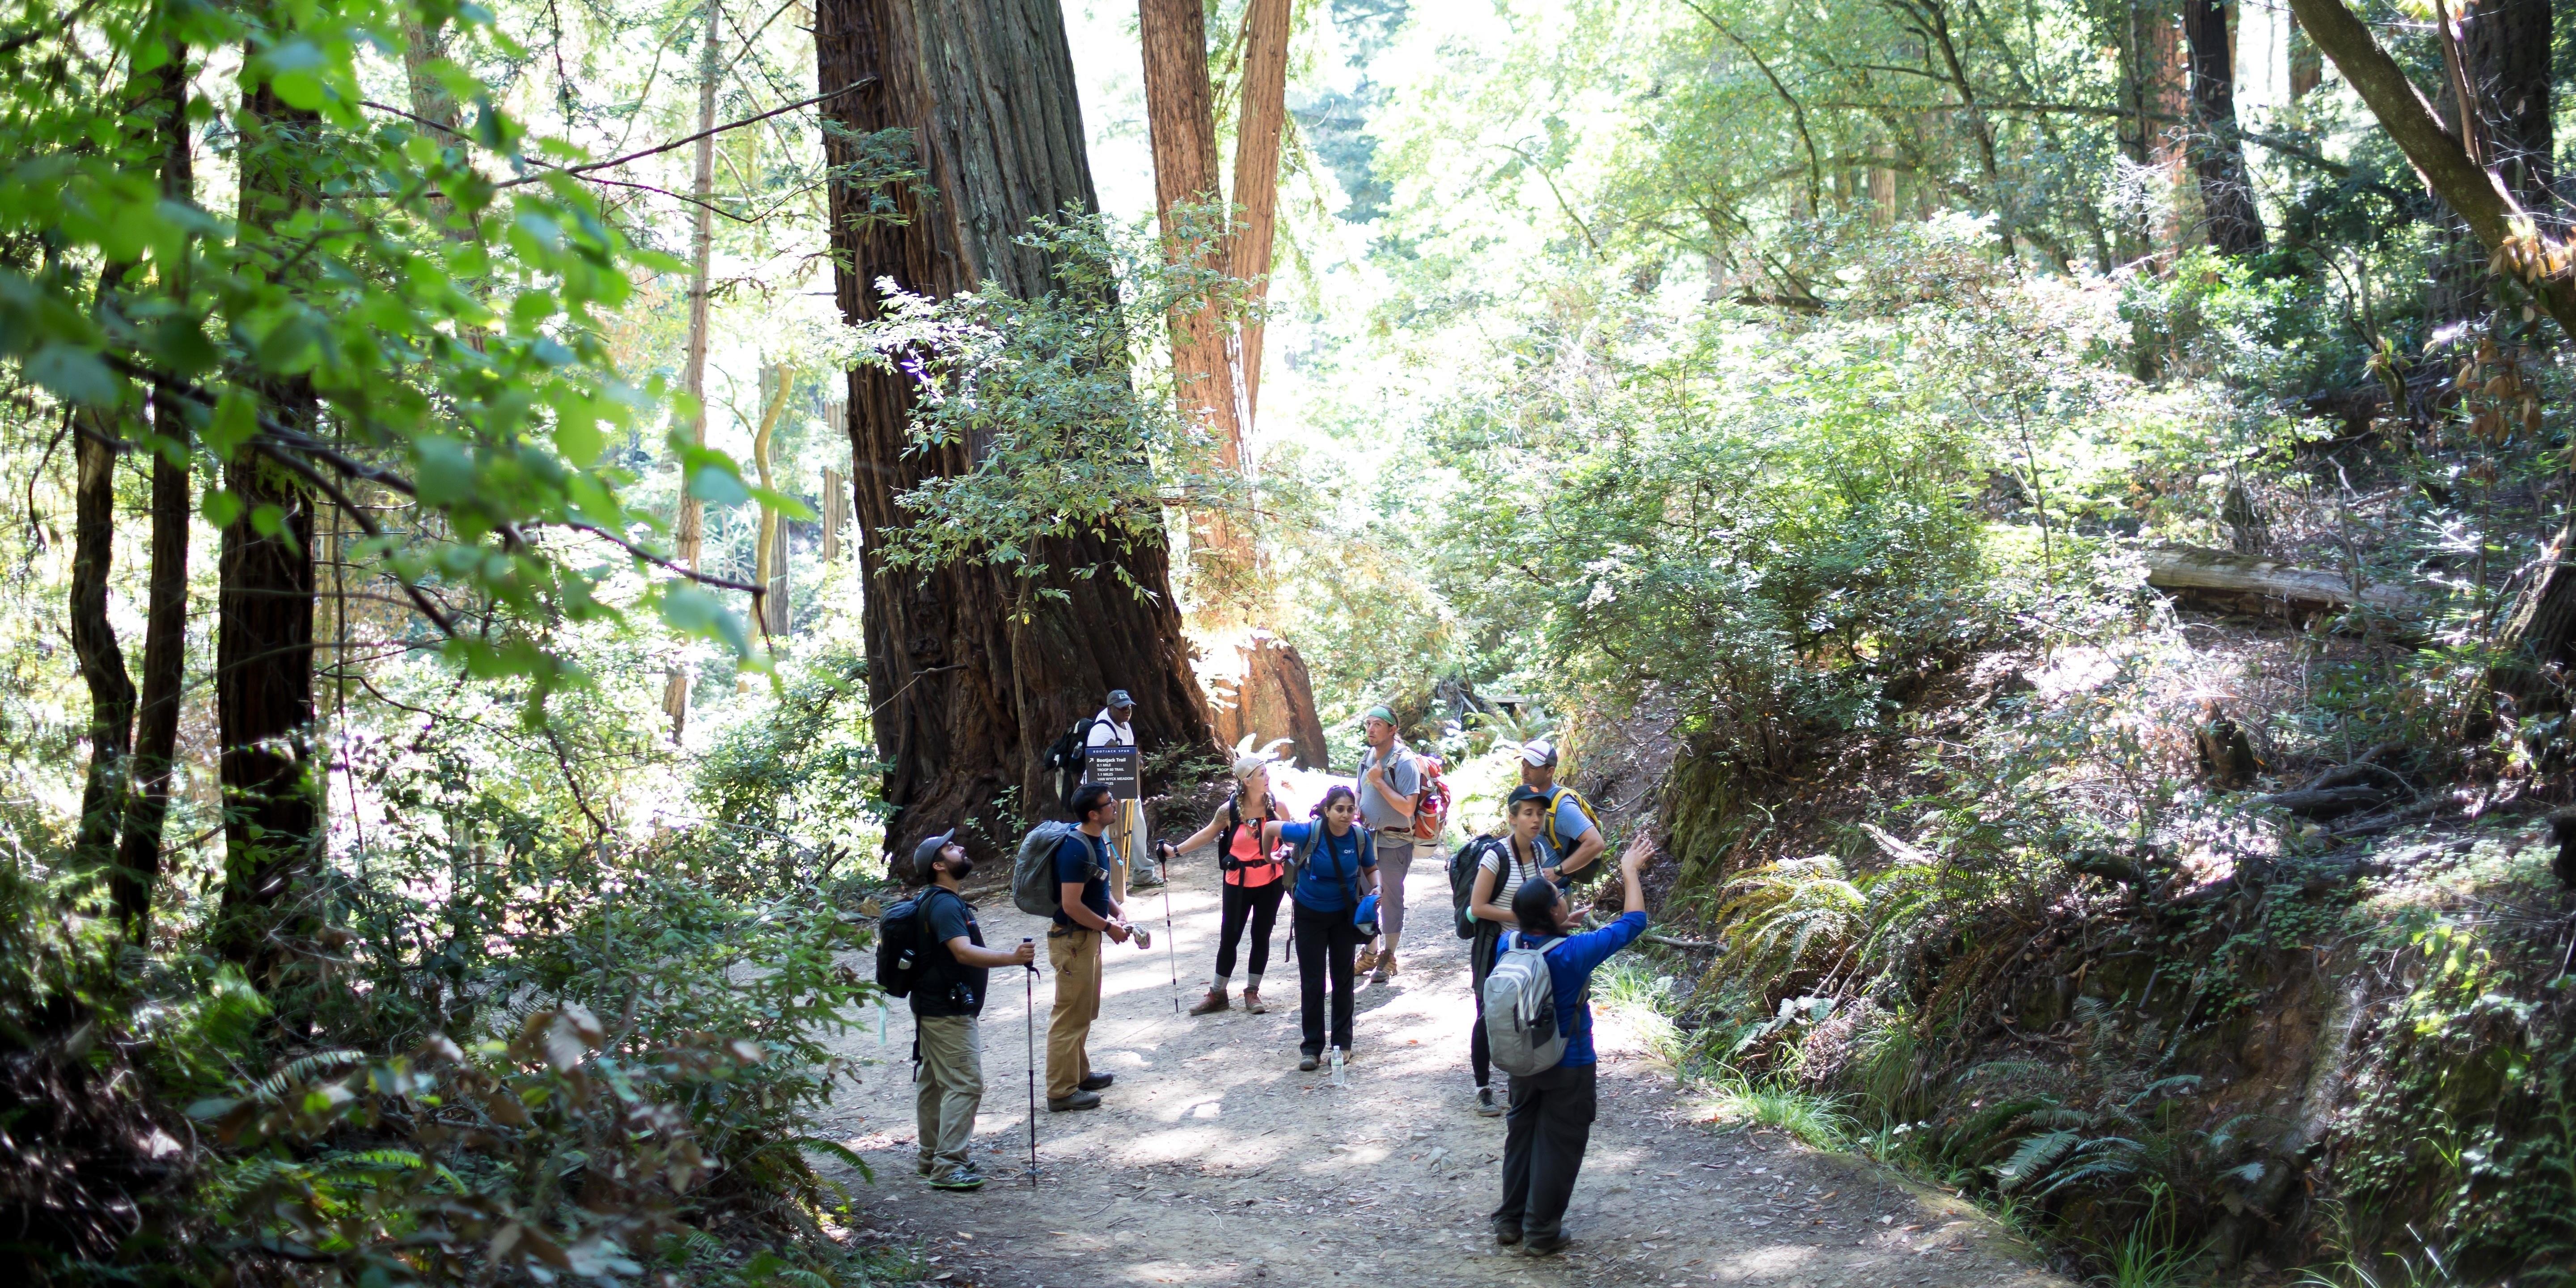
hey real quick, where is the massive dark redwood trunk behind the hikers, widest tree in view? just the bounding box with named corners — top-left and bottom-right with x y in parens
top-left (814, 0), bottom-right (1216, 876)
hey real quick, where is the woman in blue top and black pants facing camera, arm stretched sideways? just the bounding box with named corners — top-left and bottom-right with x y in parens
top-left (1262, 783), bottom-right (1378, 1072)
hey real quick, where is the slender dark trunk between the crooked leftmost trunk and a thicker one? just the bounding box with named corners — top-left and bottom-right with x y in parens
top-left (108, 22), bottom-right (196, 943)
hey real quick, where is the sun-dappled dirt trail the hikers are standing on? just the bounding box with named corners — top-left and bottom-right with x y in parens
top-left (827, 860), bottom-right (2066, 1288)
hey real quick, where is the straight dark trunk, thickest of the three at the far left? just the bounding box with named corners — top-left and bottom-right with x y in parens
top-left (214, 75), bottom-right (322, 968)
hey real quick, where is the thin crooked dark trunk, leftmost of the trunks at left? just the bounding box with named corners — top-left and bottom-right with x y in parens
top-left (70, 417), bottom-right (134, 868)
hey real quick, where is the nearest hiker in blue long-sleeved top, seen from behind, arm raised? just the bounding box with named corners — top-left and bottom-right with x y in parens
top-left (1491, 832), bottom-right (1654, 1252)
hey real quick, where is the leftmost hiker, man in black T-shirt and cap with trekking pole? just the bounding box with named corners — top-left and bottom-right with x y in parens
top-left (912, 827), bottom-right (1038, 1190)
